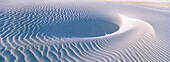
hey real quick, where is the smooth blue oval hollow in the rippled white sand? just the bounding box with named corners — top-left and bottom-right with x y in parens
top-left (44, 20), bottom-right (119, 37)
